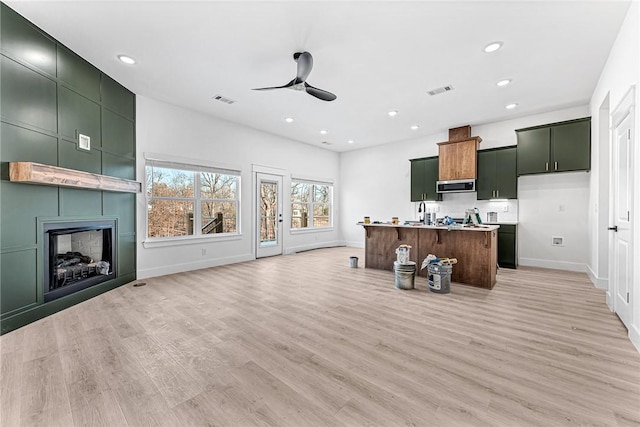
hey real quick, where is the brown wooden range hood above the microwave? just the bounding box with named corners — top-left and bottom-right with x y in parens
top-left (438, 125), bottom-right (482, 181)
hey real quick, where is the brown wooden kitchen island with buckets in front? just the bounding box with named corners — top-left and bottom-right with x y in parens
top-left (359, 223), bottom-right (500, 289)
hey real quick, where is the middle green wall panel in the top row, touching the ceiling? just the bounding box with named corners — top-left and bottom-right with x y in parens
top-left (58, 46), bottom-right (100, 102)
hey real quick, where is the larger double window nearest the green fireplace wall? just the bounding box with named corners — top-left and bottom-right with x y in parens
top-left (145, 160), bottom-right (240, 239)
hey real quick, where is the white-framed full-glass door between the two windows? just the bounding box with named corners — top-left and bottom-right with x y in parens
top-left (256, 173), bottom-right (282, 258)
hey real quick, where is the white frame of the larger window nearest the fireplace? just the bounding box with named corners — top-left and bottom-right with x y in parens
top-left (144, 158), bottom-right (242, 242)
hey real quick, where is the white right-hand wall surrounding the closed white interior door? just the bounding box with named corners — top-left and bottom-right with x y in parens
top-left (588, 1), bottom-right (640, 350)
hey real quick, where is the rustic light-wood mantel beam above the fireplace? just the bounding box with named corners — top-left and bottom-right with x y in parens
top-left (9, 162), bottom-right (142, 193)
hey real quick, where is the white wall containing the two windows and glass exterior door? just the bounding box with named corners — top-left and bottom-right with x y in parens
top-left (136, 95), bottom-right (341, 278)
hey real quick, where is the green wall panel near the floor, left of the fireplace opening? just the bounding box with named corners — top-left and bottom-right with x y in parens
top-left (0, 249), bottom-right (38, 314)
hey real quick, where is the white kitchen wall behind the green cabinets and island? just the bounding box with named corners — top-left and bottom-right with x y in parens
top-left (340, 105), bottom-right (589, 271)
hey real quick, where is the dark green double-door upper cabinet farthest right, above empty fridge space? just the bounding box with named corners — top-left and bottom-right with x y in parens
top-left (516, 117), bottom-right (591, 176)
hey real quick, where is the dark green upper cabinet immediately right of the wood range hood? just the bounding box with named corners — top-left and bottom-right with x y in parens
top-left (476, 146), bottom-right (518, 200)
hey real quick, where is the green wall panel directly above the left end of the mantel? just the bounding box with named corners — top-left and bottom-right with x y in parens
top-left (0, 123), bottom-right (58, 180)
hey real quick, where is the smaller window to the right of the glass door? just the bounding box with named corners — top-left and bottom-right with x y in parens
top-left (291, 181), bottom-right (333, 229)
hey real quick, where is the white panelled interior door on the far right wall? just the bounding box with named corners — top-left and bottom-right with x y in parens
top-left (609, 95), bottom-right (634, 328)
